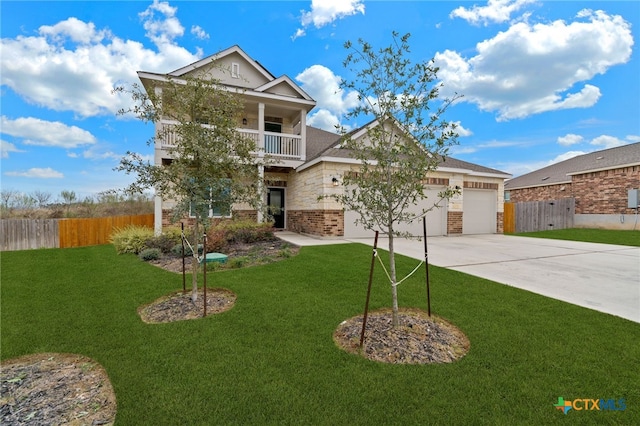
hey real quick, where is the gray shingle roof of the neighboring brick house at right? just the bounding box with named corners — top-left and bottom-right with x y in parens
top-left (505, 143), bottom-right (640, 189)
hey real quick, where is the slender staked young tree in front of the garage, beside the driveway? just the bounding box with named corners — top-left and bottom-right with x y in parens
top-left (335, 32), bottom-right (460, 326)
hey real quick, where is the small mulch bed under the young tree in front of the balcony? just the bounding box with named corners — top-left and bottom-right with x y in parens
top-left (138, 288), bottom-right (236, 324)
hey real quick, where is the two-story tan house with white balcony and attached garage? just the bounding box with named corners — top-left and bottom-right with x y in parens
top-left (138, 46), bottom-right (510, 237)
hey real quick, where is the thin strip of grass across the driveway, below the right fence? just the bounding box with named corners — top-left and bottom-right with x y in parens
top-left (508, 228), bottom-right (640, 246)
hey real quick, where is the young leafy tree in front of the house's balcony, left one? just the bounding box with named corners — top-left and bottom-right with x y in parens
top-left (115, 68), bottom-right (262, 302)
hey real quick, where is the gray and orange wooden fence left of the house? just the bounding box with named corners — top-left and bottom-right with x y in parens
top-left (0, 214), bottom-right (154, 251)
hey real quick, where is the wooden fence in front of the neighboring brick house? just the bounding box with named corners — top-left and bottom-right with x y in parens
top-left (504, 198), bottom-right (575, 232)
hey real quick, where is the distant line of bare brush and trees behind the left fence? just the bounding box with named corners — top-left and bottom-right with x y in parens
top-left (0, 189), bottom-right (153, 219)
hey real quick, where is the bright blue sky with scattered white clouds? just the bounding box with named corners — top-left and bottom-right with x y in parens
top-left (0, 0), bottom-right (640, 199)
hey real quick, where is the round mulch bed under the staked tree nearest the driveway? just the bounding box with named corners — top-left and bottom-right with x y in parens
top-left (333, 309), bottom-right (470, 364)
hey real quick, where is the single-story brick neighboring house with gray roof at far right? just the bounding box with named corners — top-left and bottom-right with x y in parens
top-left (505, 143), bottom-right (640, 229)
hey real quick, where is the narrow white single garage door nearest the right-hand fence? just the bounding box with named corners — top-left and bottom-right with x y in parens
top-left (462, 189), bottom-right (498, 234)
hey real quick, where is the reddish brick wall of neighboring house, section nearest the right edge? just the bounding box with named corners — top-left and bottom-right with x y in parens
top-left (572, 166), bottom-right (640, 214)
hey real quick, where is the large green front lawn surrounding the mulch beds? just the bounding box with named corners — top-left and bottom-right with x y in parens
top-left (1, 244), bottom-right (640, 425)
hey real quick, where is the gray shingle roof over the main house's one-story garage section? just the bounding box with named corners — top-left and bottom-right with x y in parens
top-left (298, 120), bottom-right (511, 179)
